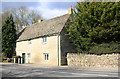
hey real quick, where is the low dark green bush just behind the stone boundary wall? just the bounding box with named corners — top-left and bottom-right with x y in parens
top-left (89, 43), bottom-right (120, 54)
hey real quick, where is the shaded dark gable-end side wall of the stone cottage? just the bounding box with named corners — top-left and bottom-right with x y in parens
top-left (60, 27), bottom-right (76, 65)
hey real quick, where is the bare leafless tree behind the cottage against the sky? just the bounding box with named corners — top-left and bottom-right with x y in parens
top-left (2, 6), bottom-right (42, 32)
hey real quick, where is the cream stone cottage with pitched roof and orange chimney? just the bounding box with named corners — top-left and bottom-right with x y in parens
top-left (16, 8), bottom-right (75, 66)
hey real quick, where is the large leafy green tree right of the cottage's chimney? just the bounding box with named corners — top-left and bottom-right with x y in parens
top-left (67, 2), bottom-right (120, 53)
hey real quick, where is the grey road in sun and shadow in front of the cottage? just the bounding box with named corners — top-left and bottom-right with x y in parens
top-left (1, 64), bottom-right (118, 77)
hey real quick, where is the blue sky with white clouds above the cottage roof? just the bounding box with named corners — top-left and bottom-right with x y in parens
top-left (2, 1), bottom-right (76, 19)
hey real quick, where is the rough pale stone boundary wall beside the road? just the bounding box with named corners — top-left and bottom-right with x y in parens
top-left (67, 53), bottom-right (120, 67)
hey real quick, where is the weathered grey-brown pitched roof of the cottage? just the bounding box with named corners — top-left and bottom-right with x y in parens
top-left (17, 14), bottom-right (70, 41)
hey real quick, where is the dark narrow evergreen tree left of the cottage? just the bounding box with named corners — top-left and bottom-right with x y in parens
top-left (2, 15), bottom-right (17, 57)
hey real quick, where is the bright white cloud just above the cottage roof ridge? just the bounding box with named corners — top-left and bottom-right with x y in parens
top-left (31, 2), bottom-right (68, 19)
